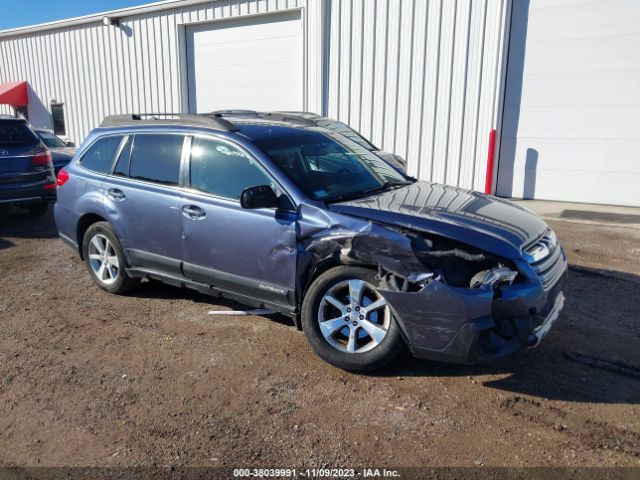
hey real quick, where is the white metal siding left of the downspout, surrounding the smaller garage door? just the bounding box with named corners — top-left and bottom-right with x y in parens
top-left (0, 0), bottom-right (322, 142)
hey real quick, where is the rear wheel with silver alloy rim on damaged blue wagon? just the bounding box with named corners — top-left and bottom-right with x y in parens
top-left (82, 222), bottom-right (140, 294)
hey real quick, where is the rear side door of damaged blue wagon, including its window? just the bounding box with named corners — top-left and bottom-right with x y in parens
top-left (102, 133), bottom-right (185, 275)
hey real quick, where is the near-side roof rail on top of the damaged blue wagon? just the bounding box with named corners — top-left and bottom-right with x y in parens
top-left (100, 113), bottom-right (238, 132)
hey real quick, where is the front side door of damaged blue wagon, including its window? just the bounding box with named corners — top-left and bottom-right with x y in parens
top-left (181, 137), bottom-right (296, 305)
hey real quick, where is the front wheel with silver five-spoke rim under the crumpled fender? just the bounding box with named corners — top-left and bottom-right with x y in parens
top-left (302, 266), bottom-right (404, 372)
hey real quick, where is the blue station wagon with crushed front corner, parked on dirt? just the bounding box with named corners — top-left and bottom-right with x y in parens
top-left (55, 115), bottom-right (567, 371)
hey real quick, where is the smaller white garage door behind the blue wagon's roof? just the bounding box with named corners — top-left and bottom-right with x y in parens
top-left (186, 11), bottom-right (303, 113)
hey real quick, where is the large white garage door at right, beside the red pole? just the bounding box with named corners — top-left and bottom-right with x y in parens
top-left (497, 0), bottom-right (640, 206)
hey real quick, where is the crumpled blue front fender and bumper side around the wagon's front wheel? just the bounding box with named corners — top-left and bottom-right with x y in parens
top-left (298, 205), bottom-right (493, 342)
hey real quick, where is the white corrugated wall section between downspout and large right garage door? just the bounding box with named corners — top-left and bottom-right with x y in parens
top-left (328, 0), bottom-right (508, 189)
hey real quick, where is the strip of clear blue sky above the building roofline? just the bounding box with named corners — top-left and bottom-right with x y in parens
top-left (0, 0), bottom-right (157, 30)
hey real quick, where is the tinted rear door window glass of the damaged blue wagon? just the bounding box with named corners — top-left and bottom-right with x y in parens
top-left (129, 134), bottom-right (184, 185)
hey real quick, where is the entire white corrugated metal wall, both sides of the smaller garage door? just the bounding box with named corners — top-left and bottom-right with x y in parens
top-left (0, 0), bottom-right (508, 189)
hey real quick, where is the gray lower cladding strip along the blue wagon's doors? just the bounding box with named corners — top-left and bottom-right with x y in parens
top-left (125, 249), bottom-right (296, 315)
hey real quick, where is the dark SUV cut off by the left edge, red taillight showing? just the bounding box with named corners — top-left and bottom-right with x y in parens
top-left (0, 116), bottom-right (56, 215)
